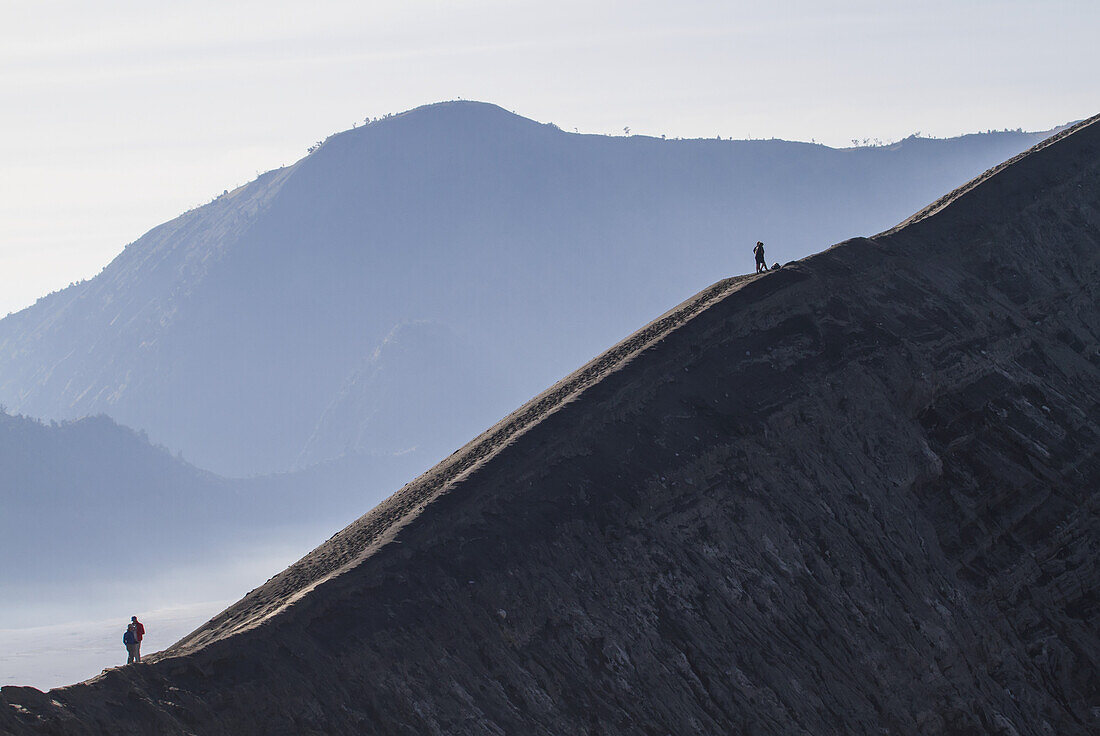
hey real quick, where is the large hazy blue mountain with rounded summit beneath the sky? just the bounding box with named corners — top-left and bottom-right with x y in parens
top-left (0, 102), bottom-right (1060, 475)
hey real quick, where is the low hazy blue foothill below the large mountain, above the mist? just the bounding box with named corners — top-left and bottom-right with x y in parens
top-left (0, 411), bottom-right (419, 598)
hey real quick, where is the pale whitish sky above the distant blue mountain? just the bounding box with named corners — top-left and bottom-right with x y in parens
top-left (0, 0), bottom-right (1100, 316)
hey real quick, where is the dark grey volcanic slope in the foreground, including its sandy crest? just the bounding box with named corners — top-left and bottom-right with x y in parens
top-left (0, 118), bottom-right (1100, 735)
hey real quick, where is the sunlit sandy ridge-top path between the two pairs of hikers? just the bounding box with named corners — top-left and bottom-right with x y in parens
top-left (165, 268), bottom-right (765, 661)
